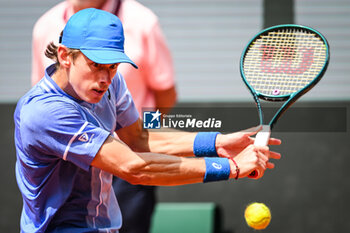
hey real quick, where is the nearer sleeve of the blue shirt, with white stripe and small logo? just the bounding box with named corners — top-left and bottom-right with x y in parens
top-left (20, 98), bottom-right (109, 171)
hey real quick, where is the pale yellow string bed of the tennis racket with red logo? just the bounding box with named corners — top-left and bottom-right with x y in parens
top-left (243, 28), bottom-right (327, 95)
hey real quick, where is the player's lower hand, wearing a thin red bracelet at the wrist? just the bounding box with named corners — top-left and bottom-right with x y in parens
top-left (235, 145), bottom-right (281, 179)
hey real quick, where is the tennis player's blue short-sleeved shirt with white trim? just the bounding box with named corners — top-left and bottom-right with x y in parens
top-left (14, 65), bottom-right (139, 233)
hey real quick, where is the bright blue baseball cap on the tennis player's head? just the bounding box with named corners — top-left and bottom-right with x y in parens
top-left (60, 8), bottom-right (137, 68)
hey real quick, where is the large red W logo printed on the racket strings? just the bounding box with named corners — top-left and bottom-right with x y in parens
top-left (260, 45), bottom-right (314, 74)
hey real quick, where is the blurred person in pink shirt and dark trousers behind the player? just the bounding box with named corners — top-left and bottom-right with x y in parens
top-left (31, 0), bottom-right (176, 233)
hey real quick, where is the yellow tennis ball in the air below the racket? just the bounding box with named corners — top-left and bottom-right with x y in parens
top-left (244, 202), bottom-right (271, 230)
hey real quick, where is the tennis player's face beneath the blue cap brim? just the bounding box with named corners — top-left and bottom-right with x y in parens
top-left (66, 53), bottom-right (119, 103)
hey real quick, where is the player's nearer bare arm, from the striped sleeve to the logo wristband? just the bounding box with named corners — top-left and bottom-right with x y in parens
top-left (91, 137), bottom-right (236, 185)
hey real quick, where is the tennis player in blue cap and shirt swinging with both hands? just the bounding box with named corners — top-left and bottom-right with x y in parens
top-left (14, 8), bottom-right (280, 232)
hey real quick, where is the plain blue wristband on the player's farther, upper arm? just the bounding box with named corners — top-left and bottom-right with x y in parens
top-left (193, 132), bottom-right (220, 157)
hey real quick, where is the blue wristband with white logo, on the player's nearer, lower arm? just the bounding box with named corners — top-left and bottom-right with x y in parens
top-left (203, 158), bottom-right (231, 183)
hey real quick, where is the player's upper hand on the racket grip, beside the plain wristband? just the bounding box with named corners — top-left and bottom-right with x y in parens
top-left (215, 126), bottom-right (281, 158)
